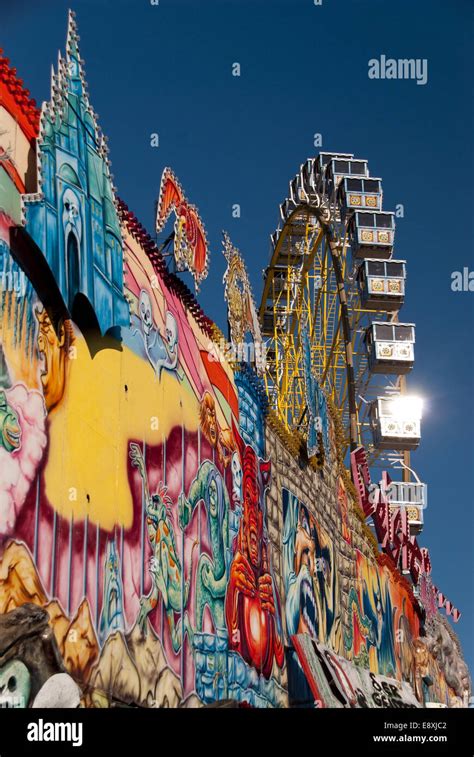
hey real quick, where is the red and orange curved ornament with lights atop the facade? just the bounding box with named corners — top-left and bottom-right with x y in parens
top-left (156, 168), bottom-right (209, 291)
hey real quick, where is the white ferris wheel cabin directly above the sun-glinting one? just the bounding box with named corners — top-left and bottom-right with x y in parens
top-left (365, 321), bottom-right (415, 375)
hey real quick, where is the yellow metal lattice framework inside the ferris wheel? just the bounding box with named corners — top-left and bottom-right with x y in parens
top-left (260, 207), bottom-right (346, 430)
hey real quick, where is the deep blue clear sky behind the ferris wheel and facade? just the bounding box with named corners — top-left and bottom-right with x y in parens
top-left (0, 0), bottom-right (474, 669)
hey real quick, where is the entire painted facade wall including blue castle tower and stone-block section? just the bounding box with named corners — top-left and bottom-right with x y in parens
top-left (0, 17), bottom-right (469, 707)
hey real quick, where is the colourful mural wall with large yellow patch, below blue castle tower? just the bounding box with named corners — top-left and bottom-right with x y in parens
top-left (0, 164), bottom-right (284, 706)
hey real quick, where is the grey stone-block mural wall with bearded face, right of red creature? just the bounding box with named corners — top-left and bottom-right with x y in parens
top-left (266, 419), bottom-right (469, 706)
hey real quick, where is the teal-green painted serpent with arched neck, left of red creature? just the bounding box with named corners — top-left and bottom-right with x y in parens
top-left (178, 460), bottom-right (230, 632)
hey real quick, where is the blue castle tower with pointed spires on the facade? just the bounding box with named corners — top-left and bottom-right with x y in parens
top-left (23, 11), bottom-right (130, 333)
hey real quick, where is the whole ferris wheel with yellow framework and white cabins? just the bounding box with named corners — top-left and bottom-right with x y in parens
top-left (259, 152), bottom-right (426, 530)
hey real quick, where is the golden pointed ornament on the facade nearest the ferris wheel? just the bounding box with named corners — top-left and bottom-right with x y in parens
top-left (222, 231), bottom-right (265, 376)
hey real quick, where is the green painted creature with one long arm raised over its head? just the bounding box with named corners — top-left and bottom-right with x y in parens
top-left (130, 442), bottom-right (191, 652)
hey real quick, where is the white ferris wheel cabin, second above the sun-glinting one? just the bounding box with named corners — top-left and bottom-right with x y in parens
top-left (357, 260), bottom-right (406, 312)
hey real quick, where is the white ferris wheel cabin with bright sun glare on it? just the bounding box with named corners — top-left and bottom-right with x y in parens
top-left (370, 395), bottom-right (421, 451)
